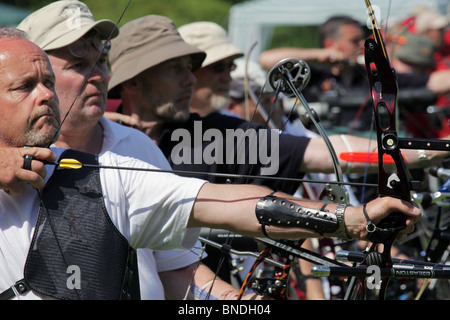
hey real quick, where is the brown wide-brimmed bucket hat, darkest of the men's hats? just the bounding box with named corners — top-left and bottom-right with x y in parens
top-left (109, 15), bottom-right (206, 98)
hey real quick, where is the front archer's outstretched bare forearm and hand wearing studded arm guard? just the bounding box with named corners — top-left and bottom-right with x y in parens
top-left (188, 183), bottom-right (421, 239)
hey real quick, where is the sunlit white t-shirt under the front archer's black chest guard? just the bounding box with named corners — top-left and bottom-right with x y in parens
top-left (0, 128), bottom-right (205, 299)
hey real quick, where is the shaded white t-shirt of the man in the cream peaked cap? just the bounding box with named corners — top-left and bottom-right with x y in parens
top-left (100, 117), bottom-right (206, 300)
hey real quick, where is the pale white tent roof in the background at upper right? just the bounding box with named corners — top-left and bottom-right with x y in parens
top-left (228, 0), bottom-right (450, 60)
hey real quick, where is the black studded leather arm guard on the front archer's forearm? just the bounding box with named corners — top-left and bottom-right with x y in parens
top-left (256, 195), bottom-right (339, 238)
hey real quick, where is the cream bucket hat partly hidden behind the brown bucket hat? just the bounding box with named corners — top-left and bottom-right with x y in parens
top-left (178, 21), bottom-right (244, 67)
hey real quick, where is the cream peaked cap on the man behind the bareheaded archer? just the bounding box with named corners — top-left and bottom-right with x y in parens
top-left (17, 0), bottom-right (119, 51)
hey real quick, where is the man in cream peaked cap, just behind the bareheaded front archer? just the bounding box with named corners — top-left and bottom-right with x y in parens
top-left (18, 1), bottom-right (260, 300)
